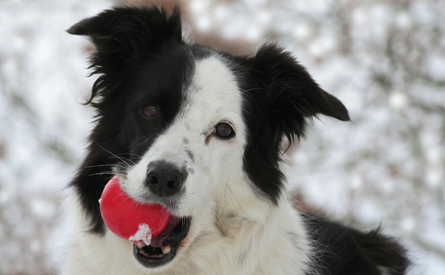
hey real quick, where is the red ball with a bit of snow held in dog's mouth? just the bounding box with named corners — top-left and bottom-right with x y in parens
top-left (99, 176), bottom-right (171, 245)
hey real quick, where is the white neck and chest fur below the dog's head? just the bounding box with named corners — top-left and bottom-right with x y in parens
top-left (62, 168), bottom-right (312, 275)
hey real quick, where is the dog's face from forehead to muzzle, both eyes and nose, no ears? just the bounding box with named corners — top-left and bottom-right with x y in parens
top-left (122, 54), bottom-right (246, 213)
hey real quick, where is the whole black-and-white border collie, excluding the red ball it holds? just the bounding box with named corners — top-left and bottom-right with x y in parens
top-left (61, 7), bottom-right (410, 275)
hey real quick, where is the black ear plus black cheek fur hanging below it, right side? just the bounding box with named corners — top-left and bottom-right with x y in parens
top-left (241, 44), bottom-right (349, 203)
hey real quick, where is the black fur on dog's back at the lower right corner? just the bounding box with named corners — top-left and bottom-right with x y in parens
top-left (305, 215), bottom-right (410, 275)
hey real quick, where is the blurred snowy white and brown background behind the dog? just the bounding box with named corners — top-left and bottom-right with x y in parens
top-left (0, 0), bottom-right (445, 275)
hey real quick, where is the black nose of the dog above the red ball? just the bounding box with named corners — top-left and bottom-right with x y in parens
top-left (147, 162), bottom-right (184, 197)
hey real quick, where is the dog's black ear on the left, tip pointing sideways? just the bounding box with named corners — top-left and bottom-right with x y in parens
top-left (67, 7), bottom-right (183, 105)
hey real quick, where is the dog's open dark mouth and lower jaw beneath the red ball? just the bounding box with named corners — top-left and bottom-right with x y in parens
top-left (133, 216), bottom-right (191, 268)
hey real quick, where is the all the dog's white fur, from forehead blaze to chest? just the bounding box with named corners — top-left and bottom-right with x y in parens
top-left (62, 57), bottom-right (311, 275)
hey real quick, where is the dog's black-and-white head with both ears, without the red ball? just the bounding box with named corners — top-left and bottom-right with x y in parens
top-left (68, 8), bottom-right (349, 268)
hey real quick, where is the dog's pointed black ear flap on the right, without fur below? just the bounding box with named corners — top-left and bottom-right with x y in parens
top-left (251, 44), bottom-right (349, 141)
